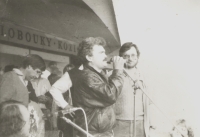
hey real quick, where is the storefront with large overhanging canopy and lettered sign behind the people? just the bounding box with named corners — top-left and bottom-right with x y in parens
top-left (0, 0), bottom-right (120, 71)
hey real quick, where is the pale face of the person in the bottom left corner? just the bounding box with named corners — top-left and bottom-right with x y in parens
top-left (19, 105), bottom-right (30, 137)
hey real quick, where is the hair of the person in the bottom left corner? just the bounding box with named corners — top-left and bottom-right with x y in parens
top-left (0, 100), bottom-right (25, 136)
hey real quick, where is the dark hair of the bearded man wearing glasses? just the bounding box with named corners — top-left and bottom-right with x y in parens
top-left (119, 42), bottom-right (140, 57)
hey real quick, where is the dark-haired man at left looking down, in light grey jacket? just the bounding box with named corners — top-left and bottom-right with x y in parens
top-left (0, 54), bottom-right (46, 106)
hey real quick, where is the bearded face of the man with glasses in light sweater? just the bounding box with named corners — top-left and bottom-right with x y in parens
top-left (122, 47), bottom-right (138, 68)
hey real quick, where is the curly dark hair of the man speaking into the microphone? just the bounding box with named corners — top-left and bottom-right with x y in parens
top-left (77, 37), bottom-right (106, 64)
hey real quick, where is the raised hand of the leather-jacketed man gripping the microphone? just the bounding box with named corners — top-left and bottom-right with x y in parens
top-left (113, 56), bottom-right (125, 70)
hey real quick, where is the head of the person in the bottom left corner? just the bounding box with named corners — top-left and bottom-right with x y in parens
top-left (0, 100), bottom-right (30, 137)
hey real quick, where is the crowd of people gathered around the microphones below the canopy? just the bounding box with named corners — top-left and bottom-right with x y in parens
top-left (0, 37), bottom-right (194, 137)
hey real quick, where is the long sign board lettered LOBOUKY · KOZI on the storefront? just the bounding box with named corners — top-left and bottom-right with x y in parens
top-left (0, 21), bottom-right (78, 55)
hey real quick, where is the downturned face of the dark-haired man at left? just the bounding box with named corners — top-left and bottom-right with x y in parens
top-left (25, 66), bottom-right (42, 81)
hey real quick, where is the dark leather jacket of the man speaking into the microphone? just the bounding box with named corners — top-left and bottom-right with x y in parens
top-left (69, 65), bottom-right (124, 135)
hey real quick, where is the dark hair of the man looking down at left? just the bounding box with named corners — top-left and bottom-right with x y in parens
top-left (22, 54), bottom-right (46, 71)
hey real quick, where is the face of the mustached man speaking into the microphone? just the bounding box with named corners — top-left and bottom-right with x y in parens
top-left (87, 45), bottom-right (108, 71)
